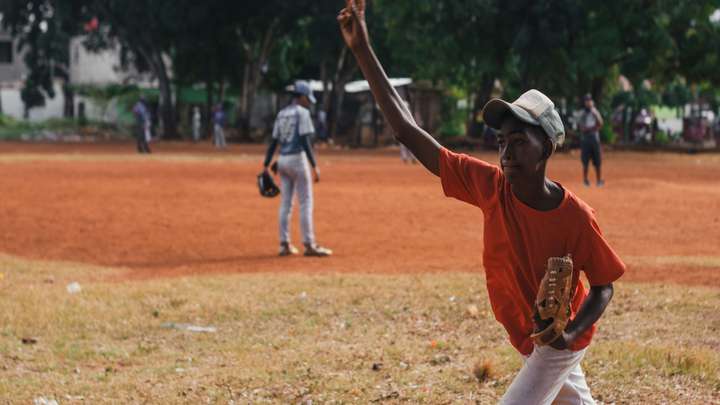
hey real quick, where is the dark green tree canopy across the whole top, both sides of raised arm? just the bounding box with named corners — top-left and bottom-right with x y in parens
top-left (0, 0), bottom-right (720, 136)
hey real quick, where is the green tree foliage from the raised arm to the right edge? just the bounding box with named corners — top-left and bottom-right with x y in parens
top-left (373, 0), bottom-right (720, 129)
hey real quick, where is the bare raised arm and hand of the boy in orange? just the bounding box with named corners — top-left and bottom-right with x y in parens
top-left (338, 0), bottom-right (441, 176)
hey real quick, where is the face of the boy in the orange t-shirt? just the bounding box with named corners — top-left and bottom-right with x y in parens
top-left (498, 116), bottom-right (549, 184)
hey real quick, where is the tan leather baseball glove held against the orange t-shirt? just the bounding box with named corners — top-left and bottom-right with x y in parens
top-left (530, 255), bottom-right (574, 346)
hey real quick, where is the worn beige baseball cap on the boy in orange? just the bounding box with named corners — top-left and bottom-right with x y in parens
top-left (482, 89), bottom-right (565, 147)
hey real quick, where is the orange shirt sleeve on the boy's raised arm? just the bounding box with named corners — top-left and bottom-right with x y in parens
top-left (440, 148), bottom-right (502, 210)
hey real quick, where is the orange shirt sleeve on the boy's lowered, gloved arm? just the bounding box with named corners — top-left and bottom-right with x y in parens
top-left (577, 213), bottom-right (626, 286)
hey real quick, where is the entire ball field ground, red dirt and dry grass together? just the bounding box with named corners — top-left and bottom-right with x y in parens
top-left (0, 144), bottom-right (720, 404)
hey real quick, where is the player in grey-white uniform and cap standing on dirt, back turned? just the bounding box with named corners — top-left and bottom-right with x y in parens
top-left (264, 81), bottom-right (332, 257)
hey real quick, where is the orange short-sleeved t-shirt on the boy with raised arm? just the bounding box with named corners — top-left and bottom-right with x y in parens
top-left (440, 148), bottom-right (625, 355)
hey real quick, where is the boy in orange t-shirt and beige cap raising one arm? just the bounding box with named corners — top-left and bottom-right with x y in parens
top-left (338, 0), bottom-right (625, 405)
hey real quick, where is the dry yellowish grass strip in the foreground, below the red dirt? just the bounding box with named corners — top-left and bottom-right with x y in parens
top-left (0, 256), bottom-right (720, 404)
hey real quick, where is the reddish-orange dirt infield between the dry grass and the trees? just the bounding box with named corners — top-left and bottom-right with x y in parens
top-left (0, 143), bottom-right (720, 286)
